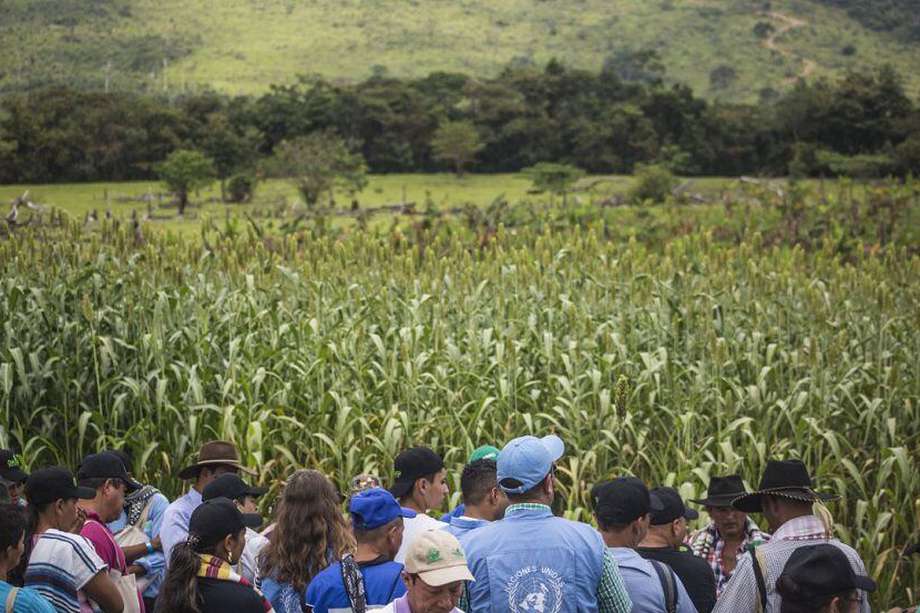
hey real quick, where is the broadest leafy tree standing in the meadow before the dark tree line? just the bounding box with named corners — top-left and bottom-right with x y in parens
top-left (271, 132), bottom-right (367, 206)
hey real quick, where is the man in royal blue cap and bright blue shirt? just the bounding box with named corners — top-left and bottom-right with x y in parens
top-left (305, 487), bottom-right (415, 613)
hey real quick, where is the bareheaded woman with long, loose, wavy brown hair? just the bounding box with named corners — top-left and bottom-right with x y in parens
top-left (259, 470), bottom-right (354, 613)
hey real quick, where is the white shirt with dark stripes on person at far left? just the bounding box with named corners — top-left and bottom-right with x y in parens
top-left (25, 530), bottom-right (108, 613)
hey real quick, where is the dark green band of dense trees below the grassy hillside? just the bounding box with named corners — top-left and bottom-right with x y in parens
top-left (0, 61), bottom-right (920, 188)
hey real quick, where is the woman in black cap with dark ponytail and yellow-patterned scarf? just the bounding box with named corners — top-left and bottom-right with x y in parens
top-left (157, 498), bottom-right (272, 613)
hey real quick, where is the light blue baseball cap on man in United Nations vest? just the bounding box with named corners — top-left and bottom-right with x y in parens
top-left (496, 434), bottom-right (565, 494)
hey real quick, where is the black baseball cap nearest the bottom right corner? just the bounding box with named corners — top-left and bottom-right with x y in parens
top-left (776, 543), bottom-right (876, 610)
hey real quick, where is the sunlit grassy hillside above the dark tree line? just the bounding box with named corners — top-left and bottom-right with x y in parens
top-left (0, 0), bottom-right (920, 100)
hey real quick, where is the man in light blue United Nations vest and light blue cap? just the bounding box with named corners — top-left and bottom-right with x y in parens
top-left (463, 435), bottom-right (632, 613)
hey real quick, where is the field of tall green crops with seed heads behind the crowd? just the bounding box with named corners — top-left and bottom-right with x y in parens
top-left (0, 221), bottom-right (920, 607)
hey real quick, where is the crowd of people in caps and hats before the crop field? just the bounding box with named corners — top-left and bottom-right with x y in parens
top-left (0, 435), bottom-right (913, 613)
